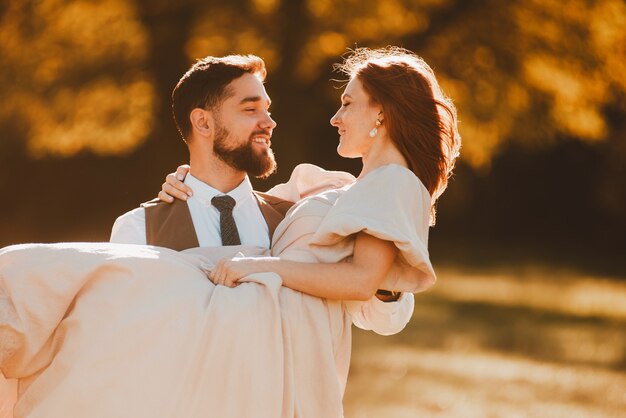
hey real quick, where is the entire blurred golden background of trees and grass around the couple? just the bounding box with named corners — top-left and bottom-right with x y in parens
top-left (0, 0), bottom-right (626, 417)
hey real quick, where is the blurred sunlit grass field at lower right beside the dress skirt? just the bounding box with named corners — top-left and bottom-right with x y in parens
top-left (345, 267), bottom-right (626, 418)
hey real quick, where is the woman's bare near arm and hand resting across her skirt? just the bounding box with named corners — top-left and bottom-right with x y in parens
top-left (209, 232), bottom-right (398, 301)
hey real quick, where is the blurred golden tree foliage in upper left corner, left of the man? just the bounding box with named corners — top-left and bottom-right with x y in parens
top-left (0, 0), bottom-right (154, 157)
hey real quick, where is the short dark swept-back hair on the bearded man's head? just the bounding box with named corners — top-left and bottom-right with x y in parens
top-left (172, 55), bottom-right (267, 141)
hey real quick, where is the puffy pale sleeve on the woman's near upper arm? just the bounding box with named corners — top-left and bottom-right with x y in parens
top-left (311, 165), bottom-right (436, 293)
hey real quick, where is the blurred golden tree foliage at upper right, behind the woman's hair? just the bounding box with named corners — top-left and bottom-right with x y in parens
top-left (414, 0), bottom-right (626, 167)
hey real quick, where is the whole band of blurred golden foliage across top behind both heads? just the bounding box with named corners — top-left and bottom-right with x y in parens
top-left (0, 0), bottom-right (626, 168)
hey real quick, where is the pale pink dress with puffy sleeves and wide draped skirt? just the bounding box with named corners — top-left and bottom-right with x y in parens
top-left (0, 165), bottom-right (435, 418)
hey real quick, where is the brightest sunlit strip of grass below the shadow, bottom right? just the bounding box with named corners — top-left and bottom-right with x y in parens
top-left (345, 346), bottom-right (626, 418)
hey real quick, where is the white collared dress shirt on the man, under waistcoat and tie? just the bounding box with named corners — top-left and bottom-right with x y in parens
top-left (110, 174), bottom-right (270, 248)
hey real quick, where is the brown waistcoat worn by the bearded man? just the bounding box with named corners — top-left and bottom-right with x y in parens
top-left (141, 191), bottom-right (293, 251)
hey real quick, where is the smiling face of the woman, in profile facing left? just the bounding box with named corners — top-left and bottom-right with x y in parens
top-left (330, 77), bottom-right (381, 158)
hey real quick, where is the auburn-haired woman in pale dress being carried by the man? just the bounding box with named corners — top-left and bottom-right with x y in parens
top-left (0, 48), bottom-right (460, 418)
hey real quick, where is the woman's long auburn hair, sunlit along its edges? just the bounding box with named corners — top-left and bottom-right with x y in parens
top-left (338, 47), bottom-right (461, 225)
